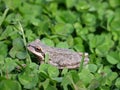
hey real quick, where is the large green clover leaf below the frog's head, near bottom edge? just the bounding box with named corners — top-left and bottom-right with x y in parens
top-left (18, 64), bottom-right (38, 89)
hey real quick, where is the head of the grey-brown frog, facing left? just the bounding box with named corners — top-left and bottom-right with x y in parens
top-left (27, 39), bottom-right (45, 60)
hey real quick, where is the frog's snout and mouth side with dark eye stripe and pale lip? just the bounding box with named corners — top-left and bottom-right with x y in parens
top-left (27, 45), bottom-right (45, 60)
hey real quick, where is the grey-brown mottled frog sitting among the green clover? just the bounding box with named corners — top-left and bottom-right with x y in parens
top-left (27, 39), bottom-right (89, 69)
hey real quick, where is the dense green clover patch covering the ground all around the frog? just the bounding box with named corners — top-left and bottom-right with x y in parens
top-left (0, 0), bottom-right (120, 90)
